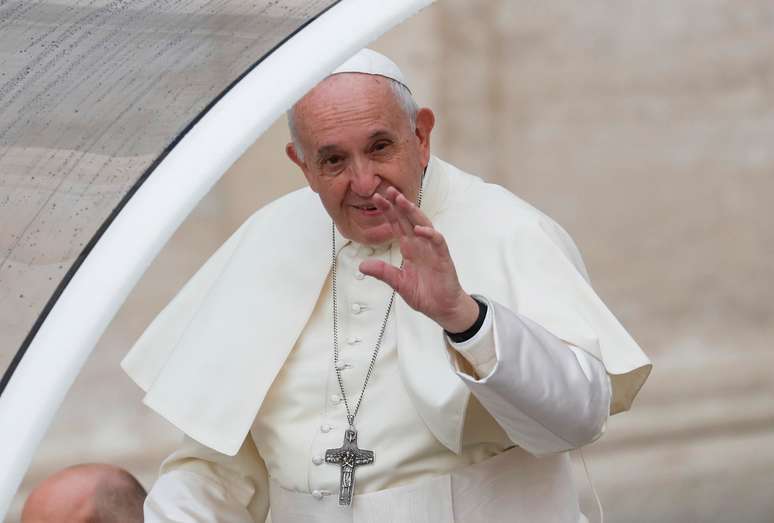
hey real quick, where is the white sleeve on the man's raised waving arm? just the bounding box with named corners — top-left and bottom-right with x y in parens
top-left (449, 296), bottom-right (611, 455)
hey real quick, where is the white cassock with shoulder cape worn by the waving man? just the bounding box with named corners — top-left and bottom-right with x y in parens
top-left (123, 158), bottom-right (650, 523)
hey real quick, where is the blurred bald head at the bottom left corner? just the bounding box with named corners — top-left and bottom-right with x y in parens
top-left (22, 464), bottom-right (146, 523)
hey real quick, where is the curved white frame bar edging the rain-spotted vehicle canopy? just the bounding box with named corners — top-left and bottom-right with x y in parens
top-left (0, 0), bottom-right (432, 518)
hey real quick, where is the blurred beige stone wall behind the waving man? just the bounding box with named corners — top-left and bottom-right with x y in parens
top-left (7, 0), bottom-right (774, 523)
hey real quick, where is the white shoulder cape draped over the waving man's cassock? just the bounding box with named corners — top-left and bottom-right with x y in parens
top-left (122, 158), bottom-right (651, 455)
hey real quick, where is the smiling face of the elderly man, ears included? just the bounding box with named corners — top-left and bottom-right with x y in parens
top-left (287, 73), bottom-right (435, 245)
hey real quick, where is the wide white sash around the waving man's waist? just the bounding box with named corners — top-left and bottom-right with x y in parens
top-left (270, 449), bottom-right (586, 523)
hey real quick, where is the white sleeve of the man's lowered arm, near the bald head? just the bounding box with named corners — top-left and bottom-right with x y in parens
top-left (143, 435), bottom-right (269, 523)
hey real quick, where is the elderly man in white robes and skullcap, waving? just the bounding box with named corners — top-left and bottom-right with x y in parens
top-left (124, 50), bottom-right (650, 523)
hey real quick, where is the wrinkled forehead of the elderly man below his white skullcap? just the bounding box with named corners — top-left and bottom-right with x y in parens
top-left (294, 73), bottom-right (406, 147)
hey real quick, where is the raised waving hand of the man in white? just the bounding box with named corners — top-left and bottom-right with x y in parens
top-left (360, 187), bottom-right (478, 332)
